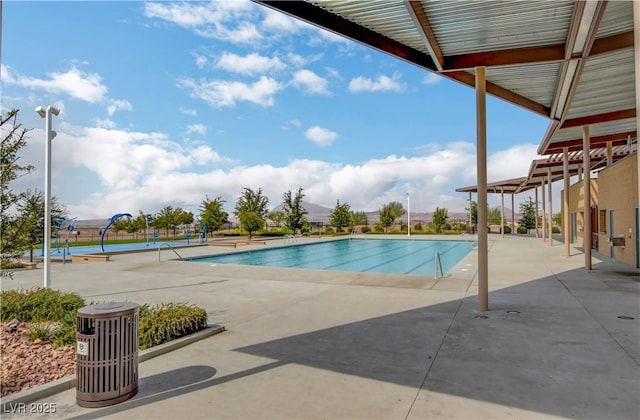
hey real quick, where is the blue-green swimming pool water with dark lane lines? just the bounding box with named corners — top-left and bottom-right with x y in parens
top-left (190, 239), bottom-right (471, 276)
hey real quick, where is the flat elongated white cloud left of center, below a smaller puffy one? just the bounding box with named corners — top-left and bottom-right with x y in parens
top-left (178, 76), bottom-right (283, 108)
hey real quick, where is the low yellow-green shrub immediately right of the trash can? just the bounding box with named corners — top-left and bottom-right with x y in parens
top-left (138, 303), bottom-right (207, 350)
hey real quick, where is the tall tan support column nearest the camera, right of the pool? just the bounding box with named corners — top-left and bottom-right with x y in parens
top-left (475, 67), bottom-right (489, 311)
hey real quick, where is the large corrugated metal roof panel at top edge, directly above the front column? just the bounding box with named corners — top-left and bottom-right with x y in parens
top-left (423, 0), bottom-right (574, 55)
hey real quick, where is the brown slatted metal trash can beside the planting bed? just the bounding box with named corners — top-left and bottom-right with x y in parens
top-left (76, 302), bottom-right (139, 407)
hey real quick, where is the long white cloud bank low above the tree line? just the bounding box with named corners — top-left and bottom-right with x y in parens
top-left (19, 118), bottom-right (559, 219)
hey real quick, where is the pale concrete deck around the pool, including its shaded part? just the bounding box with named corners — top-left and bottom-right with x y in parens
top-left (2, 235), bottom-right (640, 419)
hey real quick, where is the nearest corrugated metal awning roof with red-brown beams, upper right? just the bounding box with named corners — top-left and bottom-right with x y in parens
top-left (254, 0), bottom-right (637, 155)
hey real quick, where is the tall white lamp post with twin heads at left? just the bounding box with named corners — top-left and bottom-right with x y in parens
top-left (36, 106), bottom-right (60, 288)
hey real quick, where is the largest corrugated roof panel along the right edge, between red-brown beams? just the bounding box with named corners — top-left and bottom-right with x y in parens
top-left (567, 49), bottom-right (636, 119)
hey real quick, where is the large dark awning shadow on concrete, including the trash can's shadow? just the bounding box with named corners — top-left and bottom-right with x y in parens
top-left (74, 264), bottom-right (640, 419)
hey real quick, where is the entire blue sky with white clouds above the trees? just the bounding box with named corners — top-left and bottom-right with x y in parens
top-left (1, 1), bottom-right (557, 219)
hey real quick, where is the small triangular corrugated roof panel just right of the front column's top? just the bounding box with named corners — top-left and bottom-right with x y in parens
top-left (487, 63), bottom-right (560, 107)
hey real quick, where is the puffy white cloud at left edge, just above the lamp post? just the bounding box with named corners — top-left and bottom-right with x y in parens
top-left (1, 65), bottom-right (107, 103)
